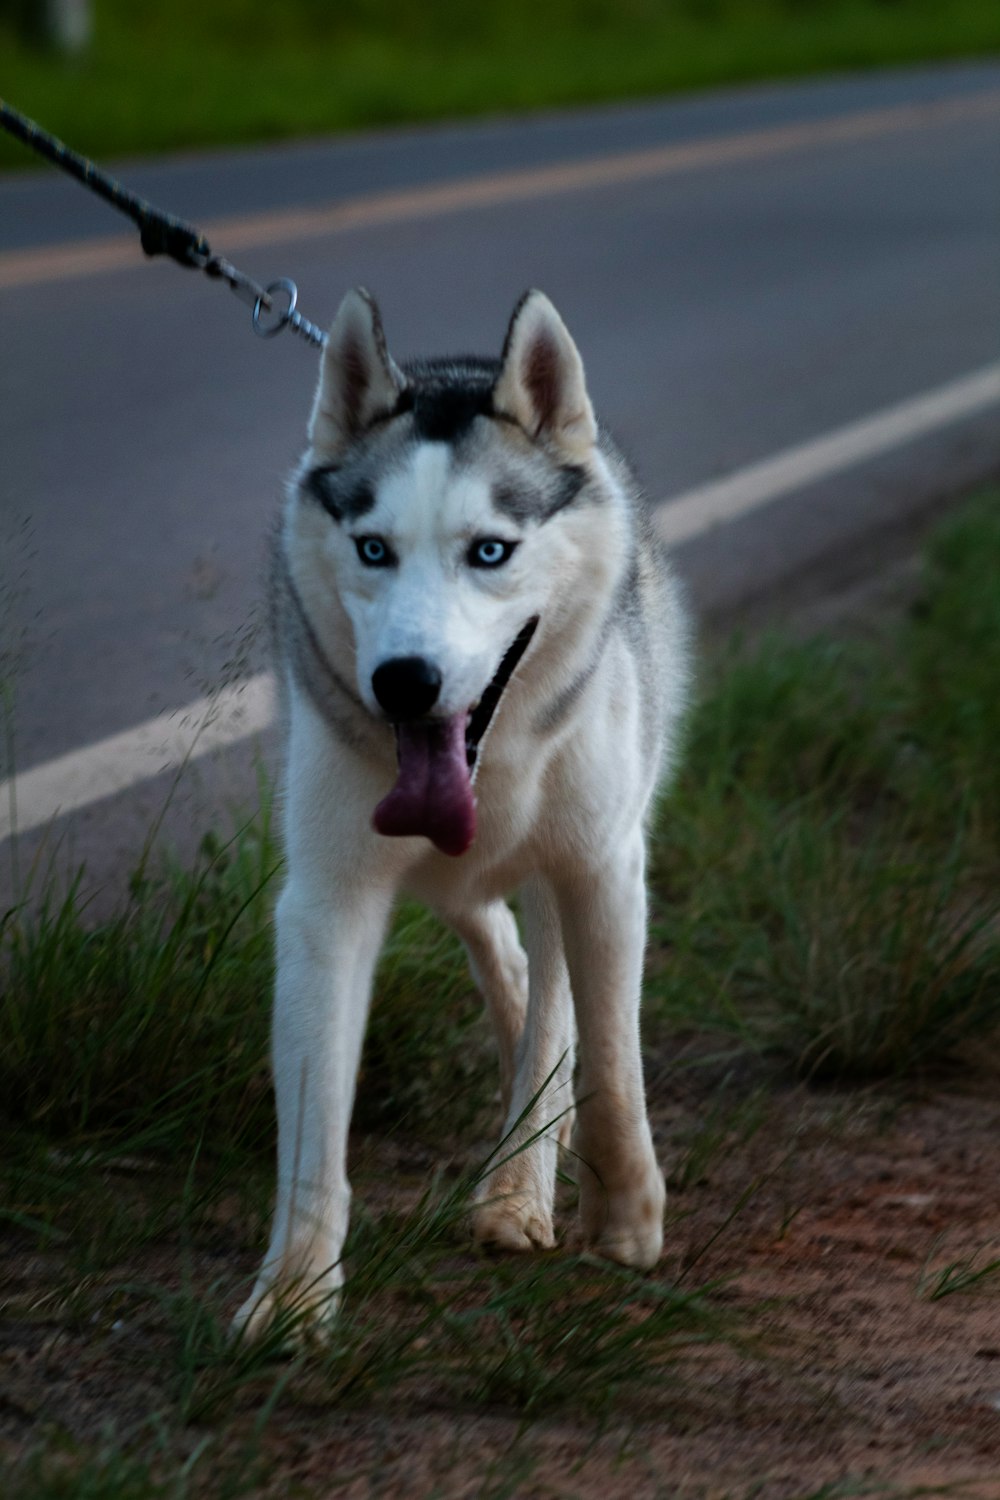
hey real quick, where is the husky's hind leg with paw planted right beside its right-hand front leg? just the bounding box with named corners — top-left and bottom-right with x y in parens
top-left (474, 879), bottom-right (573, 1250)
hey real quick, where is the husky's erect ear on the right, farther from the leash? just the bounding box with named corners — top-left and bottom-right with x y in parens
top-left (493, 291), bottom-right (597, 459)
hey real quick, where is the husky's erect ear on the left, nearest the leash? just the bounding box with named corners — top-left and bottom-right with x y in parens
top-left (309, 287), bottom-right (406, 458)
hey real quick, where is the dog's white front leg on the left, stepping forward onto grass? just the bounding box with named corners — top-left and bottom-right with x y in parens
top-left (235, 878), bottom-right (391, 1332)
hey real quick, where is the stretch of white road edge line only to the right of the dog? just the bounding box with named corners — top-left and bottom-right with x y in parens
top-left (657, 362), bottom-right (1000, 546)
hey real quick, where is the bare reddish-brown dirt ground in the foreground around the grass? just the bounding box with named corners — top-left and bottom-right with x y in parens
top-left (0, 1067), bottom-right (1000, 1500)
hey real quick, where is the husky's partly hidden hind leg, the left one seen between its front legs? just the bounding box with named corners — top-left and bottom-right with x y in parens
top-left (442, 902), bottom-right (528, 1118)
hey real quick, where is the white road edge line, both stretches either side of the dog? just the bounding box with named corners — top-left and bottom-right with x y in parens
top-left (0, 362), bottom-right (1000, 840)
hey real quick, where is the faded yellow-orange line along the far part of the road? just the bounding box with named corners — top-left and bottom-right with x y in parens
top-left (0, 90), bottom-right (1000, 288)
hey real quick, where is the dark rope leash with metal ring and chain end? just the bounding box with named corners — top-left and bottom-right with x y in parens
top-left (0, 99), bottom-right (327, 348)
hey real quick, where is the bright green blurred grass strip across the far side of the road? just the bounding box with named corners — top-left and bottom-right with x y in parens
top-left (0, 0), bottom-right (1000, 165)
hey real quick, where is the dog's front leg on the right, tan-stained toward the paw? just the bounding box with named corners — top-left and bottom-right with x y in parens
top-left (559, 833), bottom-right (666, 1268)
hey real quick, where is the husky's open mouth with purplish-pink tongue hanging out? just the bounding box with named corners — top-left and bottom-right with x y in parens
top-left (372, 615), bottom-right (538, 855)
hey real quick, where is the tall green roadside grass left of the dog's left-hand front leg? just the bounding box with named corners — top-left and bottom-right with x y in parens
top-left (0, 815), bottom-right (277, 1152)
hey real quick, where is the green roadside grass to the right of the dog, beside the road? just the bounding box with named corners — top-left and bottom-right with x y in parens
top-left (649, 494), bottom-right (1000, 1080)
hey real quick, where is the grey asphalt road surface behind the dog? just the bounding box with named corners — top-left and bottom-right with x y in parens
top-left (0, 66), bottom-right (1000, 882)
